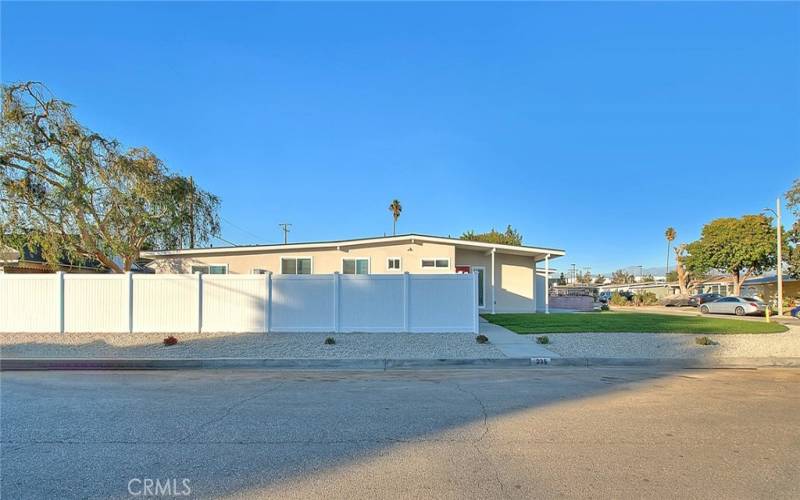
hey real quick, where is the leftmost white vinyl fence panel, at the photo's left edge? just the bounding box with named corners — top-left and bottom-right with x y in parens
top-left (0, 273), bottom-right (62, 333)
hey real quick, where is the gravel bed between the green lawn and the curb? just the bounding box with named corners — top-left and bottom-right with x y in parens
top-left (531, 326), bottom-right (800, 358)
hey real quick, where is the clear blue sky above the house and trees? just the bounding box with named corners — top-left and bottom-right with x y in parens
top-left (0, 2), bottom-right (800, 272)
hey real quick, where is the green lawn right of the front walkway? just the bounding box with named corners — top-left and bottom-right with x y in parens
top-left (482, 311), bottom-right (787, 333)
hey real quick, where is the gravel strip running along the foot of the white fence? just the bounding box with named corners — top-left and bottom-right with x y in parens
top-left (0, 333), bottom-right (505, 359)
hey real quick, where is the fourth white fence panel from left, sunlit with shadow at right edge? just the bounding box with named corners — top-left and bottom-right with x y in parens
top-left (201, 274), bottom-right (267, 332)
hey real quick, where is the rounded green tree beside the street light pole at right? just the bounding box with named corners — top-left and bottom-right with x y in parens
top-left (686, 215), bottom-right (776, 295)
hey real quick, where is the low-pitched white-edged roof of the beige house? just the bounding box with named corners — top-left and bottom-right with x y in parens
top-left (141, 234), bottom-right (566, 259)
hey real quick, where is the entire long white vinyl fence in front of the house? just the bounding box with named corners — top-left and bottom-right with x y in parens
top-left (0, 273), bottom-right (478, 333)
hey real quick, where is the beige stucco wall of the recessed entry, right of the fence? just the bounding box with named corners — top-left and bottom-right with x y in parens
top-left (456, 248), bottom-right (535, 312)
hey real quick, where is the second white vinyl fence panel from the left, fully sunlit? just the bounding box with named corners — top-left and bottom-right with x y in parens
top-left (64, 274), bottom-right (130, 333)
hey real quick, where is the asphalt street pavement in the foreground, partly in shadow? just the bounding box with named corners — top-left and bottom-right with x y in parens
top-left (0, 367), bottom-right (800, 499)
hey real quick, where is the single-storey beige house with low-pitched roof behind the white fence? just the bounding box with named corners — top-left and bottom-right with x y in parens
top-left (142, 234), bottom-right (565, 312)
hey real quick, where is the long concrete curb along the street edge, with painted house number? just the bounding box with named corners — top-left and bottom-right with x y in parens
top-left (0, 358), bottom-right (800, 371)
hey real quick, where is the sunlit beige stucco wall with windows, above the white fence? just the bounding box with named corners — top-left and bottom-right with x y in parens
top-left (151, 242), bottom-right (455, 274)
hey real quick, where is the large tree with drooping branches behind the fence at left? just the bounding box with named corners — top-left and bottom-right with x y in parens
top-left (0, 82), bottom-right (219, 273)
